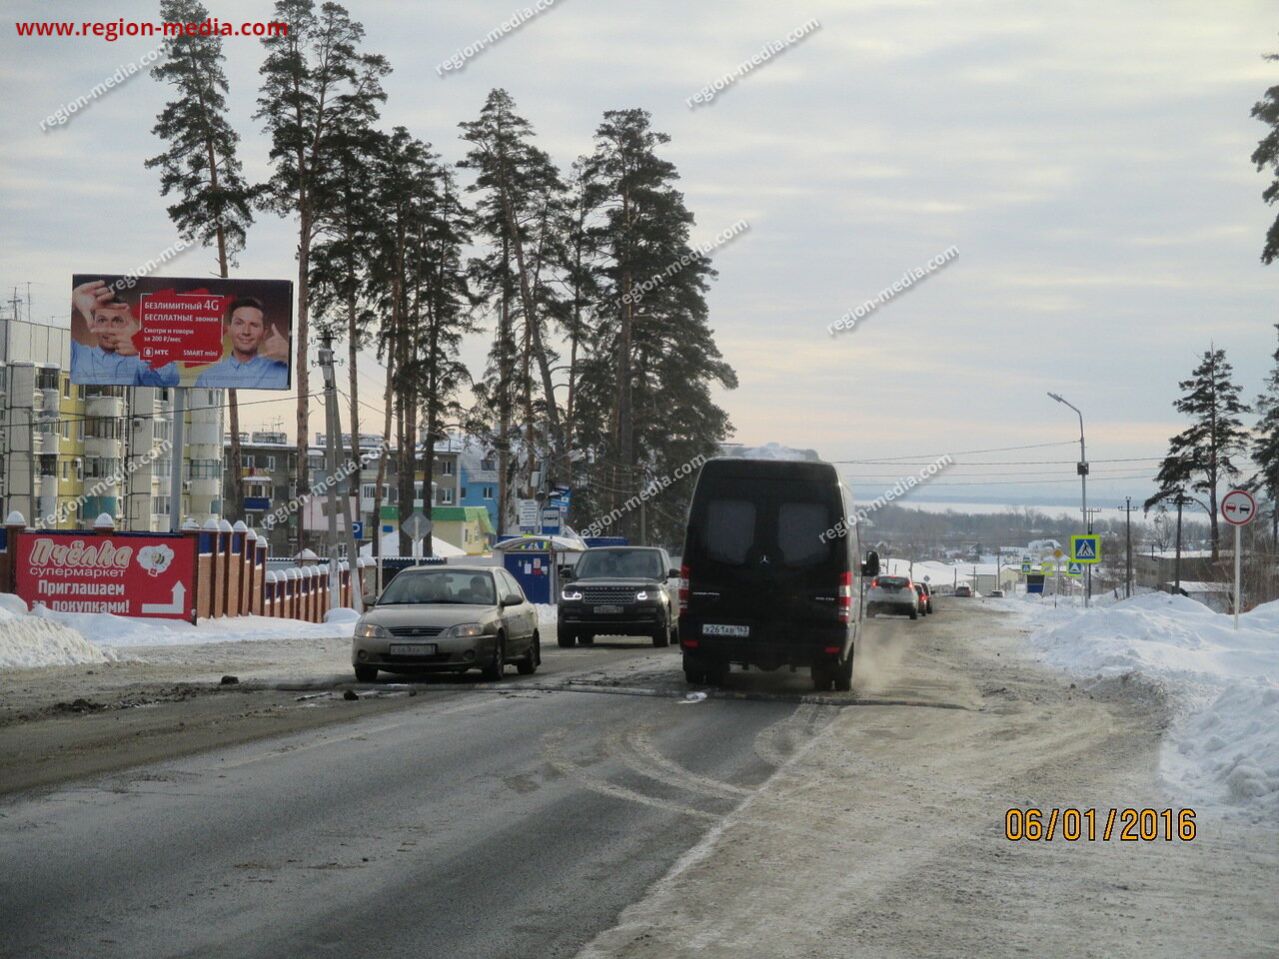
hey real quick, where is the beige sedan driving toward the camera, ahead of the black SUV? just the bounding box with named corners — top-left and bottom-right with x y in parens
top-left (350, 566), bottom-right (541, 683)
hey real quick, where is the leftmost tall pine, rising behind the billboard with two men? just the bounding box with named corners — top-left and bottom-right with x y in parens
top-left (146, 0), bottom-right (253, 519)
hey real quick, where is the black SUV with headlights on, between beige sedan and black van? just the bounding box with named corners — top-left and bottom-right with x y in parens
top-left (558, 546), bottom-right (679, 646)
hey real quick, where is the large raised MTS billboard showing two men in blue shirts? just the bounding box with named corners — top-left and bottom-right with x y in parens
top-left (70, 274), bottom-right (293, 390)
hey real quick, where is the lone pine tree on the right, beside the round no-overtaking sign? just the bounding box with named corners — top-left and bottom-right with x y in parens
top-left (1145, 348), bottom-right (1248, 560)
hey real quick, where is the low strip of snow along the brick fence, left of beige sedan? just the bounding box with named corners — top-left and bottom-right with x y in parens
top-left (32, 606), bottom-right (356, 647)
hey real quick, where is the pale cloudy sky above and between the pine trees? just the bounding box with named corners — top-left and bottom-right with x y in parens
top-left (7, 0), bottom-right (1279, 509)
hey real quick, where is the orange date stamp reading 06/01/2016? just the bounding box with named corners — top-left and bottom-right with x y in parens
top-left (1004, 806), bottom-right (1196, 843)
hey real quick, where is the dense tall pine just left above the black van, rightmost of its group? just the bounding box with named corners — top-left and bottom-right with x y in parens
top-left (574, 110), bottom-right (737, 542)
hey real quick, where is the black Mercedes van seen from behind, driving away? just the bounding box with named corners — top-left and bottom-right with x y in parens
top-left (679, 456), bottom-right (877, 692)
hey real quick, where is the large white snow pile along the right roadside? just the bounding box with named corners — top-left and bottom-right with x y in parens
top-left (1030, 593), bottom-right (1279, 822)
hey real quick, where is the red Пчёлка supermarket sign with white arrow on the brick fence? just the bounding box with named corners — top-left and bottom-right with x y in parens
top-left (14, 533), bottom-right (196, 621)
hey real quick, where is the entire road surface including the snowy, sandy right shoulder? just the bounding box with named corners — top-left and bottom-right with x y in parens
top-left (0, 601), bottom-right (1279, 959)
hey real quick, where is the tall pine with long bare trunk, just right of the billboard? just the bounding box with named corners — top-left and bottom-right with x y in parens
top-left (255, 0), bottom-right (390, 542)
